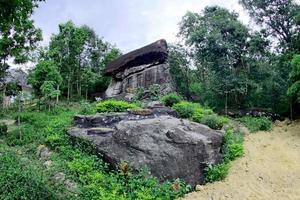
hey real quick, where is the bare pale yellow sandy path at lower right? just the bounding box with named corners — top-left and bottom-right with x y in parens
top-left (184, 120), bottom-right (300, 200)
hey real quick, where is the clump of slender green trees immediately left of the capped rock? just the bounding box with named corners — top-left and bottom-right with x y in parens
top-left (49, 21), bottom-right (119, 99)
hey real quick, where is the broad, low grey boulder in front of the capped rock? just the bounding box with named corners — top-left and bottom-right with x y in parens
top-left (68, 108), bottom-right (223, 186)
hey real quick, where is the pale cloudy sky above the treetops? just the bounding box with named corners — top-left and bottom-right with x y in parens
top-left (33, 0), bottom-right (249, 53)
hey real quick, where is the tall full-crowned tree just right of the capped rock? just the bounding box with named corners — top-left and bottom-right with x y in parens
top-left (179, 6), bottom-right (250, 109)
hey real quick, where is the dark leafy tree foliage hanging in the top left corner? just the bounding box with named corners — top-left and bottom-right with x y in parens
top-left (0, 0), bottom-right (42, 82)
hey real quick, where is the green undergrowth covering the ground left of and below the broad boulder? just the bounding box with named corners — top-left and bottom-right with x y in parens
top-left (0, 106), bottom-right (190, 200)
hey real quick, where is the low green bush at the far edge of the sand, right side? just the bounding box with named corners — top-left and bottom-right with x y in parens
top-left (240, 116), bottom-right (272, 133)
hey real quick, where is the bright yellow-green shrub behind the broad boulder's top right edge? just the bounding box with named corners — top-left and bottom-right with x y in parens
top-left (172, 101), bottom-right (203, 118)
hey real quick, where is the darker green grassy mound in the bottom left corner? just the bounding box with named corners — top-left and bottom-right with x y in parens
top-left (0, 152), bottom-right (58, 200)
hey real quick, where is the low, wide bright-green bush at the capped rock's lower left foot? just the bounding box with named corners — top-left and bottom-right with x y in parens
top-left (96, 99), bottom-right (138, 113)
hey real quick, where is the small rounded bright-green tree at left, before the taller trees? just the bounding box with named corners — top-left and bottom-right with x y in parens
top-left (29, 60), bottom-right (62, 105)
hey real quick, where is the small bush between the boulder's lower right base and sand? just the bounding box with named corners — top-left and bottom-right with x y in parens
top-left (205, 162), bottom-right (230, 182)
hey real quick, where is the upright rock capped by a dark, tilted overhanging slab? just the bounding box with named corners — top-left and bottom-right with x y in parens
top-left (105, 40), bottom-right (173, 97)
